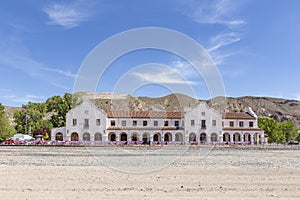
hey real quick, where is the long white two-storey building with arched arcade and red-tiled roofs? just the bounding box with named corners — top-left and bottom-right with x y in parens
top-left (51, 100), bottom-right (264, 144)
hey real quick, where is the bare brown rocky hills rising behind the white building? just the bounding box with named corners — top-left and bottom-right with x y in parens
top-left (2, 92), bottom-right (300, 127)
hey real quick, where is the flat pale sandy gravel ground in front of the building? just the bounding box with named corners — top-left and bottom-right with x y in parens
top-left (0, 146), bottom-right (300, 199)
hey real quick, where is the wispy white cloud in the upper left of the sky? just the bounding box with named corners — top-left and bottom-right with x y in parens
top-left (43, 1), bottom-right (92, 29)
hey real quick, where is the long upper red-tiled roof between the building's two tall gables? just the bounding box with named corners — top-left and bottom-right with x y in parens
top-left (106, 111), bottom-right (184, 119)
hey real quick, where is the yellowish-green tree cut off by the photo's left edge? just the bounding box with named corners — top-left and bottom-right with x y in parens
top-left (0, 103), bottom-right (16, 141)
